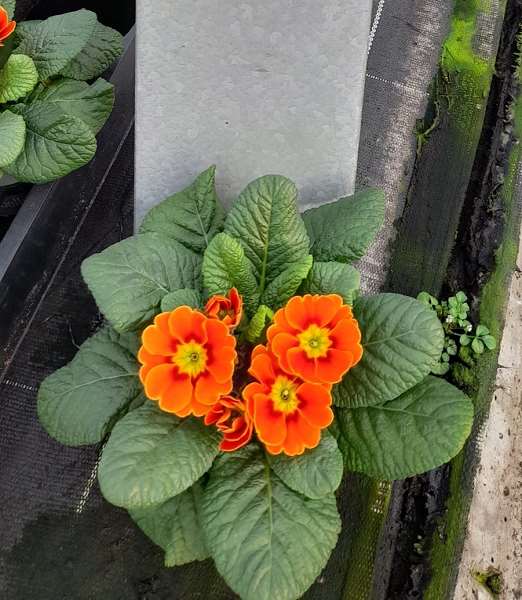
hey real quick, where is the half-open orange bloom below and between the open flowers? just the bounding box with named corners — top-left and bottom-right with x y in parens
top-left (205, 396), bottom-right (254, 452)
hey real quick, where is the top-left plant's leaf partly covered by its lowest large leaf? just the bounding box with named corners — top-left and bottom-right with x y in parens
top-left (31, 79), bottom-right (114, 134)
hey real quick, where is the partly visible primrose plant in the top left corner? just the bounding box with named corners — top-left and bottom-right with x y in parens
top-left (0, 0), bottom-right (123, 183)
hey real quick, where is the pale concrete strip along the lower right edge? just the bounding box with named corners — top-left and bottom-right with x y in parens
top-left (454, 220), bottom-right (522, 600)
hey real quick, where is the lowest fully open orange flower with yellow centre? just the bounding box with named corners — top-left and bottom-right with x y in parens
top-left (243, 346), bottom-right (333, 456)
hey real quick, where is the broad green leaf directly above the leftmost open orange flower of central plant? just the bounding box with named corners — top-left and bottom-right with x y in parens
top-left (82, 233), bottom-right (201, 331)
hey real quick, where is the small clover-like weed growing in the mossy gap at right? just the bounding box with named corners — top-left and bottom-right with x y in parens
top-left (417, 291), bottom-right (497, 377)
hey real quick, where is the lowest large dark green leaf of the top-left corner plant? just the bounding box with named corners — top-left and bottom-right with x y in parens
top-left (6, 102), bottom-right (96, 183)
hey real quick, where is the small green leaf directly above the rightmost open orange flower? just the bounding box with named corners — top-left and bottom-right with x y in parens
top-left (303, 262), bottom-right (361, 305)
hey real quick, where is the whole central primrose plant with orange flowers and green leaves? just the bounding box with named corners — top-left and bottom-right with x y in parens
top-left (38, 167), bottom-right (473, 600)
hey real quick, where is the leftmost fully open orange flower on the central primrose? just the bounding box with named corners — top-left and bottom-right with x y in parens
top-left (138, 306), bottom-right (236, 417)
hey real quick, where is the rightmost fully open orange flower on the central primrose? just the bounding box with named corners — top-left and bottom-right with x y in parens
top-left (267, 294), bottom-right (363, 383)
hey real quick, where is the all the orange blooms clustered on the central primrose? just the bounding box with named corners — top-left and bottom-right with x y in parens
top-left (138, 289), bottom-right (363, 456)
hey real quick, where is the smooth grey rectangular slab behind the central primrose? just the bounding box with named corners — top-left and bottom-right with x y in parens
top-left (136, 0), bottom-right (372, 223)
